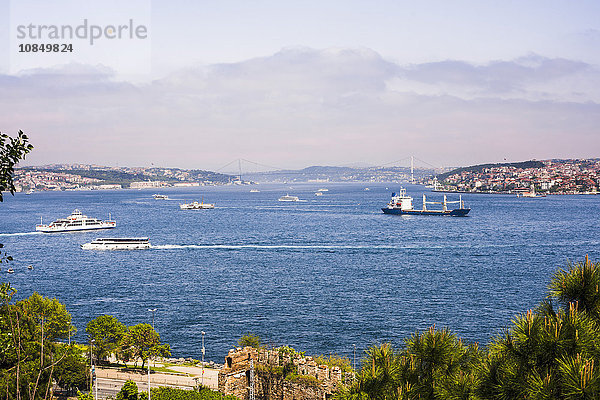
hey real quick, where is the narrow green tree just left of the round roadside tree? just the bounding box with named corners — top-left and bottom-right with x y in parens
top-left (85, 315), bottom-right (126, 362)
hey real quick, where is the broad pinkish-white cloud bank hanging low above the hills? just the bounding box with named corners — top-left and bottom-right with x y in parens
top-left (0, 47), bottom-right (600, 168)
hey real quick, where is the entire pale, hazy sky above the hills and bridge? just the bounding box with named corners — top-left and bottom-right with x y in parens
top-left (0, 0), bottom-right (600, 170)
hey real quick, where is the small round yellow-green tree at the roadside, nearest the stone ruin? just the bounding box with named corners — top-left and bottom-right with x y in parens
top-left (121, 324), bottom-right (171, 368)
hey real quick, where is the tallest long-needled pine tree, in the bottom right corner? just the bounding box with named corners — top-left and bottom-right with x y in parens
top-left (476, 257), bottom-right (600, 399)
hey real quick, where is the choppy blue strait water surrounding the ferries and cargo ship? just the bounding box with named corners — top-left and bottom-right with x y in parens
top-left (0, 183), bottom-right (600, 362)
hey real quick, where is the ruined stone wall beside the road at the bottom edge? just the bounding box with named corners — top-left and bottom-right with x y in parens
top-left (219, 347), bottom-right (342, 400)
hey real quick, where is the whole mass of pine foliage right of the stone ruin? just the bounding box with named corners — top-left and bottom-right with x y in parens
top-left (337, 257), bottom-right (600, 400)
